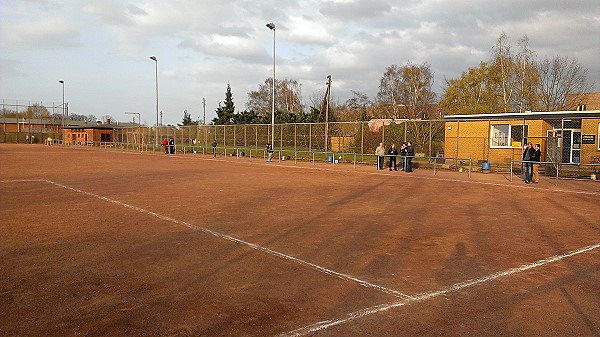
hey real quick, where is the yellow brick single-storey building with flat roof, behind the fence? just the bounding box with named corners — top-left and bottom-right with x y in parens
top-left (444, 110), bottom-right (600, 164)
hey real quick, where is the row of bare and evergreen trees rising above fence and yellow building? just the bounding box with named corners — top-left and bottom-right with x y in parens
top-left (188, 33), bottom-right (592, 125)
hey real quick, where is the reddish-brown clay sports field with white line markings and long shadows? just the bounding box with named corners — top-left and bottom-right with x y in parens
top-left (0, 144), bottom-right (600, 336)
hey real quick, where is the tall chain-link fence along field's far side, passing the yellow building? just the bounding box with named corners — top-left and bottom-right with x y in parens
top-left (0, 116), bottom-right (600, 181)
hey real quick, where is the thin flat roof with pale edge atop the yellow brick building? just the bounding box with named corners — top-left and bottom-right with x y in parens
top-left (444, 110), bottom-right (600, 122)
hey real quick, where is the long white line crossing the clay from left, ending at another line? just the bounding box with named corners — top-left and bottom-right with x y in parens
top-left (12, 180), bottom-right (414, 300)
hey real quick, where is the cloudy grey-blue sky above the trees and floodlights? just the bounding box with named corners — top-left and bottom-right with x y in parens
top-left (0, 0), bottom-right (600, 125)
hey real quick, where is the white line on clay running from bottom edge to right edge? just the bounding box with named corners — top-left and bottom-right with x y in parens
top-left (278, 244), bottom-right (600, 337)
